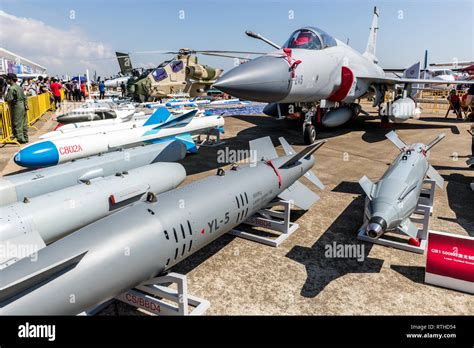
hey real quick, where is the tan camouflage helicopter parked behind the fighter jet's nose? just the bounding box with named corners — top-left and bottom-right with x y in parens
top-left (117, 48), bottom-right (259, 102)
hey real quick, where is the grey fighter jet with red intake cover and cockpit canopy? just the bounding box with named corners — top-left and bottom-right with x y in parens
top-left (214, 8), bottom-right (474, 143)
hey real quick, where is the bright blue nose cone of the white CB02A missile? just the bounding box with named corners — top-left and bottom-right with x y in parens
top-left (13, 141), bottom-right (59, 168)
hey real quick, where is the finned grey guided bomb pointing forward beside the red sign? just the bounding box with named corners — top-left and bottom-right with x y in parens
top-left (359, 131), bottom-right (445, 245)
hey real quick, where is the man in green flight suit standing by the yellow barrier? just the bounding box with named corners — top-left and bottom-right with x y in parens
top-left (5, 73), bottom-right (28, 144)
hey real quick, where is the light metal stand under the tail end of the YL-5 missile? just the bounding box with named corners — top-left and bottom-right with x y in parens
top-left (229, 201), bottom-right (299, 247)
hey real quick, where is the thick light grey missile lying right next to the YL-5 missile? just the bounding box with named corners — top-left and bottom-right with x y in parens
top-left (0, 162), bottom-right (186, 269)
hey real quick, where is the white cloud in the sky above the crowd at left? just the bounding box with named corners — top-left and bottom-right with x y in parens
top-left (0, 10), bottom-right (115, 75)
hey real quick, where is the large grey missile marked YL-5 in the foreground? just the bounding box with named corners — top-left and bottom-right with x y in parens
top-left (0, 137), bottom-right (324, 315)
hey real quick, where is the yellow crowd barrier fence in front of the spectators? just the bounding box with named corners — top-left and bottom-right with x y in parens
top-left (0, 90), bottom-right (64, 145)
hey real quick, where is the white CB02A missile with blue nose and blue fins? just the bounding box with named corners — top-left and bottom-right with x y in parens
top-left (14, 111), bottom-right (224, 168)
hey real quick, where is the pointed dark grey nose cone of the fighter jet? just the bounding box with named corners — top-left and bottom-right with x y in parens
top-left (214, 56), bottom-right (291, 103)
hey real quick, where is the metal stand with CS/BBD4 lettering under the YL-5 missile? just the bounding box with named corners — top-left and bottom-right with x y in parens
top-left (81, 273), bottom-right (210, 316)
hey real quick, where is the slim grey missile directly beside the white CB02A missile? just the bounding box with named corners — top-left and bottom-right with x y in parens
top-left (0, 140), bottom-right (186, 206)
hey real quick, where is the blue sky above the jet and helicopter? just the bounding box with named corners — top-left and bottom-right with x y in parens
top-left (0, 0), bottom-right (474, 75)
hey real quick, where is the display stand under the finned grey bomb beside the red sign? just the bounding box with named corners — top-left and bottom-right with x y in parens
top-left (357, 180), bottom-right (435, 254)
